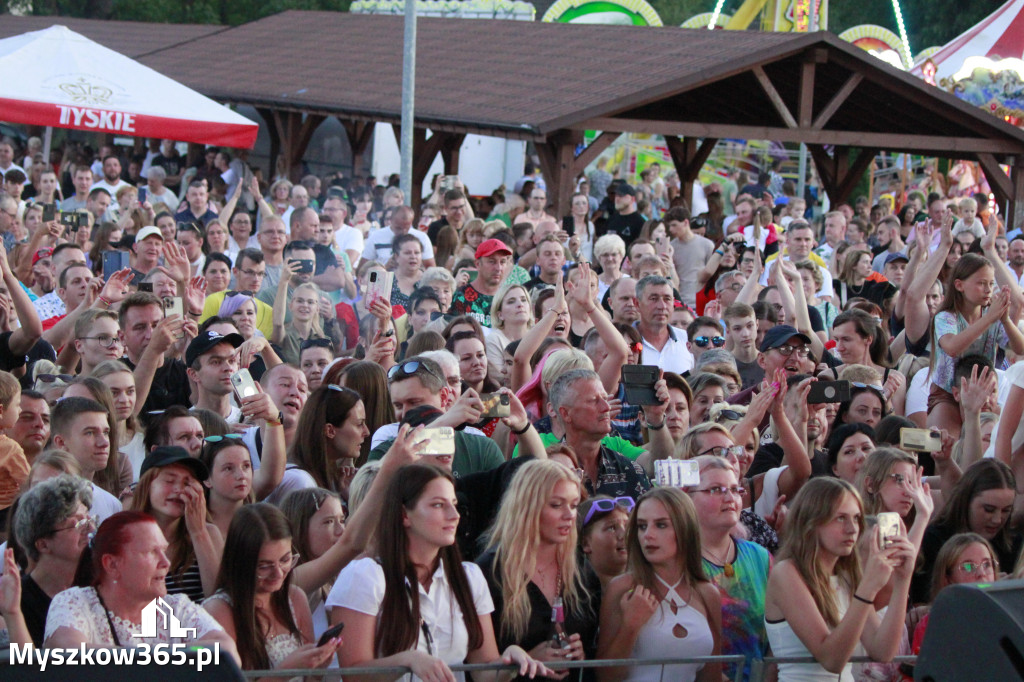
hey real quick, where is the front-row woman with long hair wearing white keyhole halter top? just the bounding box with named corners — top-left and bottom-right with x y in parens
top-left (597, 487), bottom-right (722, 682)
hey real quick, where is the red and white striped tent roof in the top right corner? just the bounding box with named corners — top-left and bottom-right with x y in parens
top-left (912, 0), bottom-right (1024, 83)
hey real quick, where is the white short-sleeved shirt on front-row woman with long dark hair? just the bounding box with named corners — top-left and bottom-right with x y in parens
top-left (326, 558), bottom-right (495, 680)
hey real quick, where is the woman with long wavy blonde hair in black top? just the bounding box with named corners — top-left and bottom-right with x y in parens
top-left (477, 461), bottom-right (597, 662)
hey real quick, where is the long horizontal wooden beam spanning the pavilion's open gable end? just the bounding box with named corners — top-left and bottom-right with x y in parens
top-left (572, 115), bottom-right (1024, 158)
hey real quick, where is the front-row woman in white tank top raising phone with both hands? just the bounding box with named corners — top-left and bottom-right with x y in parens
top-left (765, 477), bottom-right (916, 682)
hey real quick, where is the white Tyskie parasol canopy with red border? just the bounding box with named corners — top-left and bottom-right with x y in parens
top-left (0, 26), bottom-right (259, 148)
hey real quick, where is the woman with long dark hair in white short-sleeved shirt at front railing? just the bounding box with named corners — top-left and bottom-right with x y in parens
top-left (327, 464), bottom-right (551, 682)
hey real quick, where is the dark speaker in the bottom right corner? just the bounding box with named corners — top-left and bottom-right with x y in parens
top-left (913, 581), bottom-right (1024, 682)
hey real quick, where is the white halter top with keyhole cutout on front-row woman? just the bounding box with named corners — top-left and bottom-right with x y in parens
top-left (626, 574), bottom-right (715, 682)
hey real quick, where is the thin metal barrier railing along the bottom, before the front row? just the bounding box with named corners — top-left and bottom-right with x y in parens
top-left (243, 654), bottom-right (918, 682)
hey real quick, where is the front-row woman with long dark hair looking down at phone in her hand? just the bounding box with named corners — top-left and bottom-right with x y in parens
top-left (203, 503), bottom-right (341, 670)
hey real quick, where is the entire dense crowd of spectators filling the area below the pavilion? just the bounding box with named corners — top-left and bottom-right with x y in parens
top-left (0, 134), bottom-right (1024, 682)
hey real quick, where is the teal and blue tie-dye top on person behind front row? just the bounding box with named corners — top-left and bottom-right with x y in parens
top-left (702, 540), bottom-right (772, 680)
